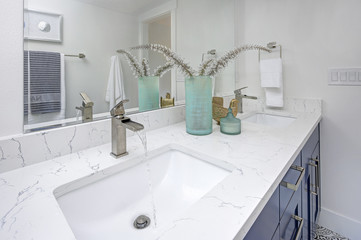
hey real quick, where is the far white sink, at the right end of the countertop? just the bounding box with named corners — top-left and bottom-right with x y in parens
top-left (243, 113), bottom-right (296, 127)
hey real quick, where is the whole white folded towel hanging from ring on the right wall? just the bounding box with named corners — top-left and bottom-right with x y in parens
top-left (260, 58), bottom-right (284, 107)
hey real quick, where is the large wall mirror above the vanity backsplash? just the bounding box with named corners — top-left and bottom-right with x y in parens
top-left (24, 0), bottom-right (235, 132)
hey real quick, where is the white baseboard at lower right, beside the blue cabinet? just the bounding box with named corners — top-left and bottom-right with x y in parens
top-left (318, 208), bottom-right (361, 240)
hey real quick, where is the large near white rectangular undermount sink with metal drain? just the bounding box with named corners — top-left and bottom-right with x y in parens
top-left (54, 149), bottom-right (233, 240)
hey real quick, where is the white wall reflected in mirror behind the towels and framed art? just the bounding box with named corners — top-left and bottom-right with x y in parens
top-left (25, 0), bottom-right (138, 118)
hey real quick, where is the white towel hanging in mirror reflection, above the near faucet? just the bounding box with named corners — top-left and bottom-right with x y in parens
top-left (105, 56), bottom-right (126, 110)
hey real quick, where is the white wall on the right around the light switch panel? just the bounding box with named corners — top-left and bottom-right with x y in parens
top-left (237, 0), bottom-right (361, 239)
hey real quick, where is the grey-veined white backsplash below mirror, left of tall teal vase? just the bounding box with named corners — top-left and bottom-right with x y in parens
top-left (0, 106), bottom-right (185, 173)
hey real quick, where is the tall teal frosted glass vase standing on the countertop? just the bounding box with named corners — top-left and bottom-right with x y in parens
top-left (185, 76), bottom-right (213, 135)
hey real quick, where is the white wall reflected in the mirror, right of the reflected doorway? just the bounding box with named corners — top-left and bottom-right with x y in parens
top-left (177, 0), bottom-right (235, 100)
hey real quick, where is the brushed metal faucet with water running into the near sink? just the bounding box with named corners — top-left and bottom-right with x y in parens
top-left (110, 99), bottom-right (144, 158)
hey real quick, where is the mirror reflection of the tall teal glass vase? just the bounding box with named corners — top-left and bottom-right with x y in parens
top-left (138, 76), bottom-right (159, 112)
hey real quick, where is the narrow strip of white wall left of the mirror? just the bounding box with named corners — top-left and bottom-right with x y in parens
top-left (0, 0), bottom-right (23, 137)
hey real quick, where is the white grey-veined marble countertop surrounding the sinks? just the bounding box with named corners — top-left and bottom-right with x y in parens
top-left (0, 109), bottom-right (321, 240)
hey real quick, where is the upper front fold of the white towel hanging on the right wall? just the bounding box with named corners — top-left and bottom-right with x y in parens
top-left (260, 58), bottom-right (282, 88)
